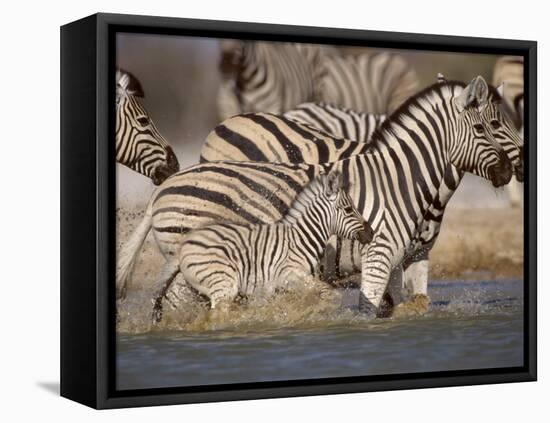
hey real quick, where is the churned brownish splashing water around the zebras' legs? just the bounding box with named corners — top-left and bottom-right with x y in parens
top-left (117, 278), bottom-right (523, 334)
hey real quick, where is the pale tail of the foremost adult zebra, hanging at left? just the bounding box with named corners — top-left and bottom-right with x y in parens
top-left (116, 197), bottom-right (154, 300)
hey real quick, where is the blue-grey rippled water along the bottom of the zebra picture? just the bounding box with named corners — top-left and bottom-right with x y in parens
top-left (117, 281), bottom-right (523, 389)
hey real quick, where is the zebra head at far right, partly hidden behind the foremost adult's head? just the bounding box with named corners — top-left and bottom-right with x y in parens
top-left (488, 84), bottom-right (523, 182)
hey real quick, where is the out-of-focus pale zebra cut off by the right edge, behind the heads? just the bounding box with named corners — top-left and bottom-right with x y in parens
top-left (493, 56), bottom-right (524, 207)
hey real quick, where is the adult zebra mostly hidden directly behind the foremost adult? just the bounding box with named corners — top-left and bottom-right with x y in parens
top-left (201, 74), bottom-right (522, 314)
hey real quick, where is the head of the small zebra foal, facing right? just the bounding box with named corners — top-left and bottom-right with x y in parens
top-left (323, 172), bottom-right (374, 244)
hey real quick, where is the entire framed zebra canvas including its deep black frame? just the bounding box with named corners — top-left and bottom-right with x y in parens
top-left (61, 14), bottom-right (537, 408)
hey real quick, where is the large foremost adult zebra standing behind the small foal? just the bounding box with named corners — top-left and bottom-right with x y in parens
top-left (117, 77), bottom-right (513, 318)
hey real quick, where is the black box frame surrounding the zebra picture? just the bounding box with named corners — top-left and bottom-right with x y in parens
top-left (61, 14), bottom-right (537, 409)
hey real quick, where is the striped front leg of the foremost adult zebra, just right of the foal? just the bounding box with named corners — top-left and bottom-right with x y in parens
top-left (359, 243), bottom-right (392, 316)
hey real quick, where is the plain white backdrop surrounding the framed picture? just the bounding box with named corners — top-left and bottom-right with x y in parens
top-left (0, 0), bottom-right (550, 423)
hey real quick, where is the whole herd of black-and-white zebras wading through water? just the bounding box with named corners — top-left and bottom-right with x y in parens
top-left (117, 41), bottom-right (523, 320)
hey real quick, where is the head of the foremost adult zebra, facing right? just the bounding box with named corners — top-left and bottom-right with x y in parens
top-left (449, 76), bottom-right (513, 187)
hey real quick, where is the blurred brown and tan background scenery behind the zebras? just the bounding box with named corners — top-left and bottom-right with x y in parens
top-left (116, 34), bottom-right (523, 279)
